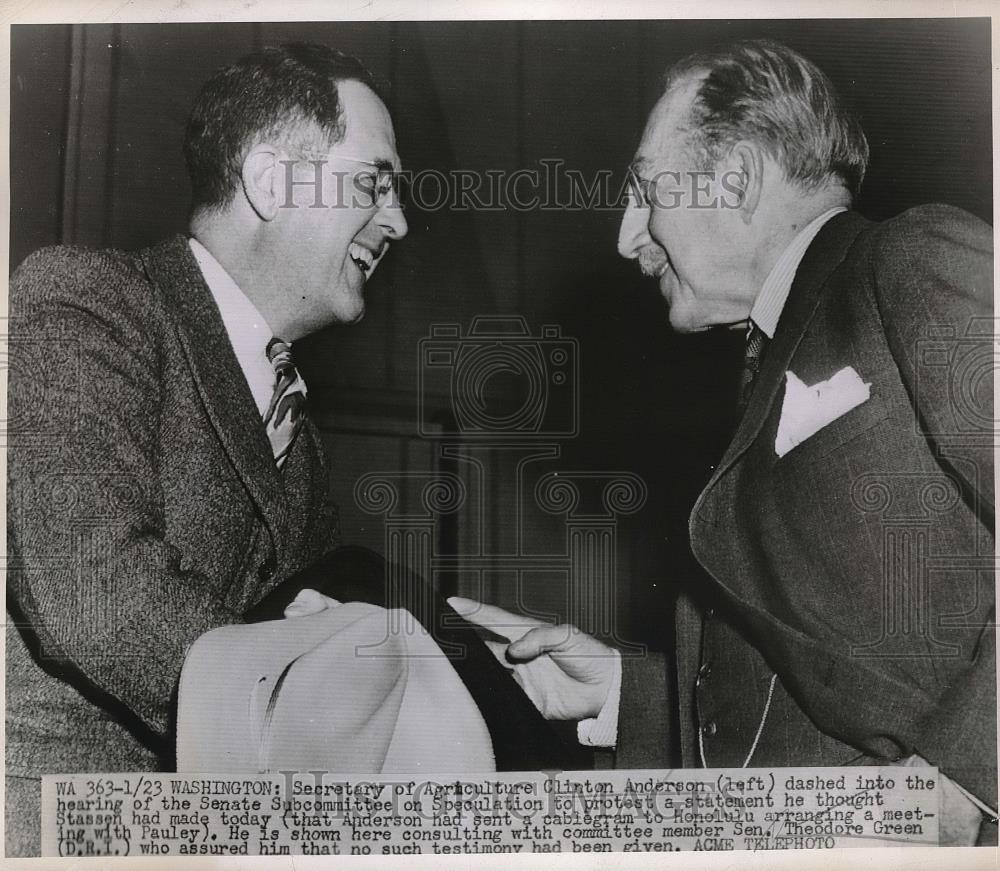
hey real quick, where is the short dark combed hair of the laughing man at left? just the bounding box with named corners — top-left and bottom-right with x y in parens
top-left (184, 43), bottom-right (378, 211)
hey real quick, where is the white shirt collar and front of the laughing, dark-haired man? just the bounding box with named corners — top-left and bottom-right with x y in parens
top-left (188, 238), bottom-right (286, 415)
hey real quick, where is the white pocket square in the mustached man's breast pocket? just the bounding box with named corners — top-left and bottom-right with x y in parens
top-left (774, 366), bottom-right (871, 457)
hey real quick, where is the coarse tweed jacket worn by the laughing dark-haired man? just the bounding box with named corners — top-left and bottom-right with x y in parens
top-left (7, 236), bottom-right (336, 777)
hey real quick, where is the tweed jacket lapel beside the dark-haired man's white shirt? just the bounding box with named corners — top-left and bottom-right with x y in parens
top-left (141, 236), bottom-right (286, 558)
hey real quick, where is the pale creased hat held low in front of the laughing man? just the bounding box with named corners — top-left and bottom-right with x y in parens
top-left (177, 602), bottom-right (496, 775)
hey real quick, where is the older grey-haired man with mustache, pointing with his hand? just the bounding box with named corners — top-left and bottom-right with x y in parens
top-left (459, 41), bottom-right (997, 844)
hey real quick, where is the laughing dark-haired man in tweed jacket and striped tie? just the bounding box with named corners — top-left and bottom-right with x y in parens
top-left (6, 45), bottom-right (407, 856)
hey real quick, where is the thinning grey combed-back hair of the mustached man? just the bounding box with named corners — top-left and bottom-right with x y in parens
top-left (664, 39), bottom-right (868, 194)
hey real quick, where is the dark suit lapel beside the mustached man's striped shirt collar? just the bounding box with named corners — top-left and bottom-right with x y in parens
top-left (695, 212), bottom-right (868, 498)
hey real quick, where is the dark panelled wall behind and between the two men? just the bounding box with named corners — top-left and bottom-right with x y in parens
top-left (11, 19), bottom-right (992, 656)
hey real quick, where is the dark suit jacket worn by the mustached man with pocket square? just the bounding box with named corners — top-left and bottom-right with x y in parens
top-left (619, 206), bottom-right (997, 807)
